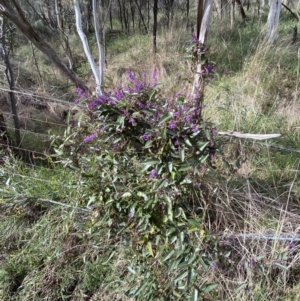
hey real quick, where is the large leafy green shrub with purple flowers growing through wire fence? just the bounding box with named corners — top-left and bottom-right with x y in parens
top-left (58, 72), bottom-right (217, 300)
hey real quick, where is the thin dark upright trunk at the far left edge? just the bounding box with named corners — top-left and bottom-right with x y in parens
top-left (0, 16), bottom-right (21, 148)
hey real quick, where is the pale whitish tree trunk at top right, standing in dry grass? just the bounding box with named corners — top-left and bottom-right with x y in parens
top-left (266, 0), bottom-right (282, 43)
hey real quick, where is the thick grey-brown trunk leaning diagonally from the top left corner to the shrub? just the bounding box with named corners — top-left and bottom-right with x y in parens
top-left (0, 0), bottom-right (88, 91)
